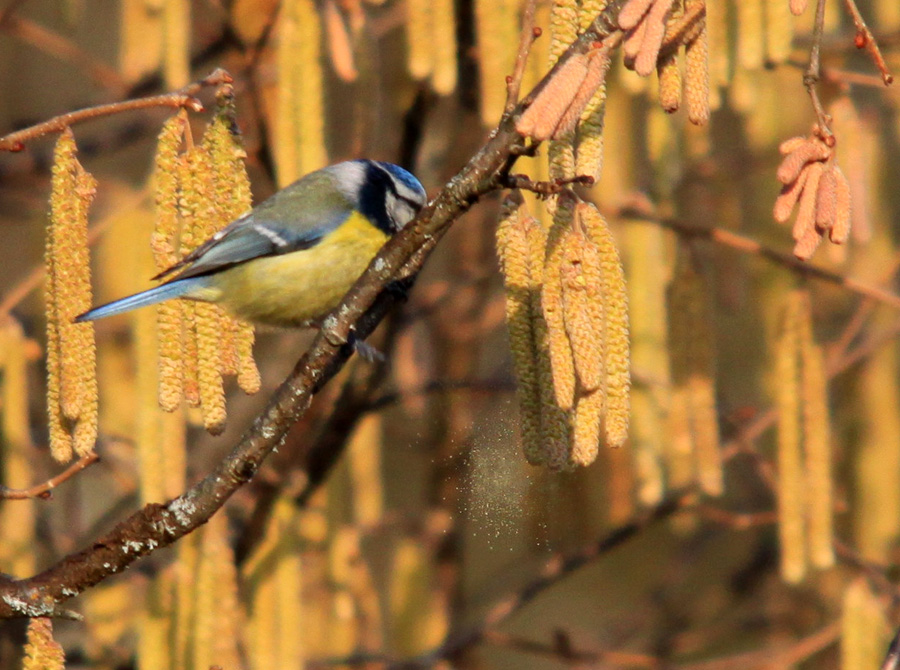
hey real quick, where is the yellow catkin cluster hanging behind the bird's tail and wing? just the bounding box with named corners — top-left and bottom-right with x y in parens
top-left (152, 108), bottom-right (260, 435)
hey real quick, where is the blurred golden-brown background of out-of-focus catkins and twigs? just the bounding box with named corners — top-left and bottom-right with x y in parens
top-left (0, 0), bottom-right (900, 670)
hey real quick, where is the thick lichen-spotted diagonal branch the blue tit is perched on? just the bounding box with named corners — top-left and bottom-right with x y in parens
top-left (0, 0), bottom-right (621, 618)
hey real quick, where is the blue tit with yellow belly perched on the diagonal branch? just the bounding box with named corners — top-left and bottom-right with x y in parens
top-left (76, 160), bottom-right (425, 327)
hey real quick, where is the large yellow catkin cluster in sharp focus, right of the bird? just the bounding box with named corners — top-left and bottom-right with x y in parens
top-left (497, 192), bottom-right (630, 470)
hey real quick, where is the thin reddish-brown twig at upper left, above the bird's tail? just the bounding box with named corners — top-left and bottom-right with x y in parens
top-left (0, 68), bottom-right (231, 151)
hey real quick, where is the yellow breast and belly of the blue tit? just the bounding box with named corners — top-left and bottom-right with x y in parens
top-left (214, 213), bottom-right (388, 326)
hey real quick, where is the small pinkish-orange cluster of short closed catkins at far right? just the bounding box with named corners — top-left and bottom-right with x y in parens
top-left (773, 128), bottom-right (850, 260)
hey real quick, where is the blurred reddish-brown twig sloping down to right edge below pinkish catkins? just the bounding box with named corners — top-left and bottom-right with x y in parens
top-left (610, 207), bottom-right (900, 309)
